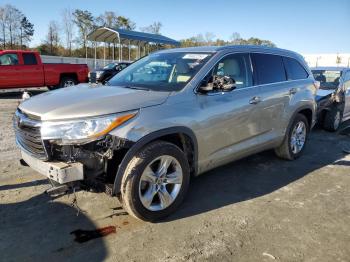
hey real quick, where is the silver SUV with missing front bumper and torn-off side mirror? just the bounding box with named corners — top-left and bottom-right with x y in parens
top-left (14, 46), bottom-right (316, 221)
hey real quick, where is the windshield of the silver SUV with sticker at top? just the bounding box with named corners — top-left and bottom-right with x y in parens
top-left (109, 52), bottom-right (212, 91)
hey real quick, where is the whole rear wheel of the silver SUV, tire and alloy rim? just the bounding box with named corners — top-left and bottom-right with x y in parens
top-left (275, 114), bottom-right (310, 160)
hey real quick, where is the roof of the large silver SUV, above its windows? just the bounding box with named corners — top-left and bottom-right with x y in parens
top-left (157, 45), bottom-right (304, 60)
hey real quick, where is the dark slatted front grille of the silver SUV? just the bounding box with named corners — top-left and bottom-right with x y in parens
top-left (13, 111), bottom-right (47, 160)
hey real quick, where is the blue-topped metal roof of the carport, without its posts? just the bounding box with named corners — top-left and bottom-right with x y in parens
top-left (87, 27), bottom-right (180, 46)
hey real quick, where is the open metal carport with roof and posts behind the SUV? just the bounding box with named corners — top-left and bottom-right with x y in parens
top-left (86, 27), bottom-right (180, 67)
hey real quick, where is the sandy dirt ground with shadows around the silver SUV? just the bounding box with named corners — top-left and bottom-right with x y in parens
top-left (0, 91), bottom-right (350, 261)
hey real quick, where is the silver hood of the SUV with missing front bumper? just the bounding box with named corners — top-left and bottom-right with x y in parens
top-left (19, 84), bottom-right (170, 120)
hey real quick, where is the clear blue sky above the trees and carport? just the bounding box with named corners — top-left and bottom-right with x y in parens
top-left (0, 0), bottom-right (350, 54)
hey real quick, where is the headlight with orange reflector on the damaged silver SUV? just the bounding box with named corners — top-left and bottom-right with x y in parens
top-left (41, 112), bottom-right (137, 144)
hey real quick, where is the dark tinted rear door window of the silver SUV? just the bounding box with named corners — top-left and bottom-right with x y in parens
top-left (251, 53), bottom-right (287, 85)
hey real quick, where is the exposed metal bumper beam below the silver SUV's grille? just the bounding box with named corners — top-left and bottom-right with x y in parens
top-left (21, 150), bottom-right (84, 184)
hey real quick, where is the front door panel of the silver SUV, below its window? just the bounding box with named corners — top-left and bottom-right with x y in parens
top-left (197, 87), bottom-right (261, 169)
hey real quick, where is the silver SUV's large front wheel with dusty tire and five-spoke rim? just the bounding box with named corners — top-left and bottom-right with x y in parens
top-left (121, 141), bottom-right (190, 222)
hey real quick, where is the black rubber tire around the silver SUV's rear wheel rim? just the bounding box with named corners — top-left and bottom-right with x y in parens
top-left (275, 114), bottom-right (310, 160)
